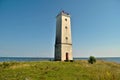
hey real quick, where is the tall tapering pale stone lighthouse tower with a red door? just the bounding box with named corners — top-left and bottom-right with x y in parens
top-left (55, 11), bottom-right (73, 61)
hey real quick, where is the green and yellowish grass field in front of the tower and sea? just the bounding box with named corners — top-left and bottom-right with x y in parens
top-left (0, 60), bottom-right (120, 80)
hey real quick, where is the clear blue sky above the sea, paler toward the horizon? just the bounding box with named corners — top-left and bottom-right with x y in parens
top-left (0, 0), bottom-right (120, 57)
